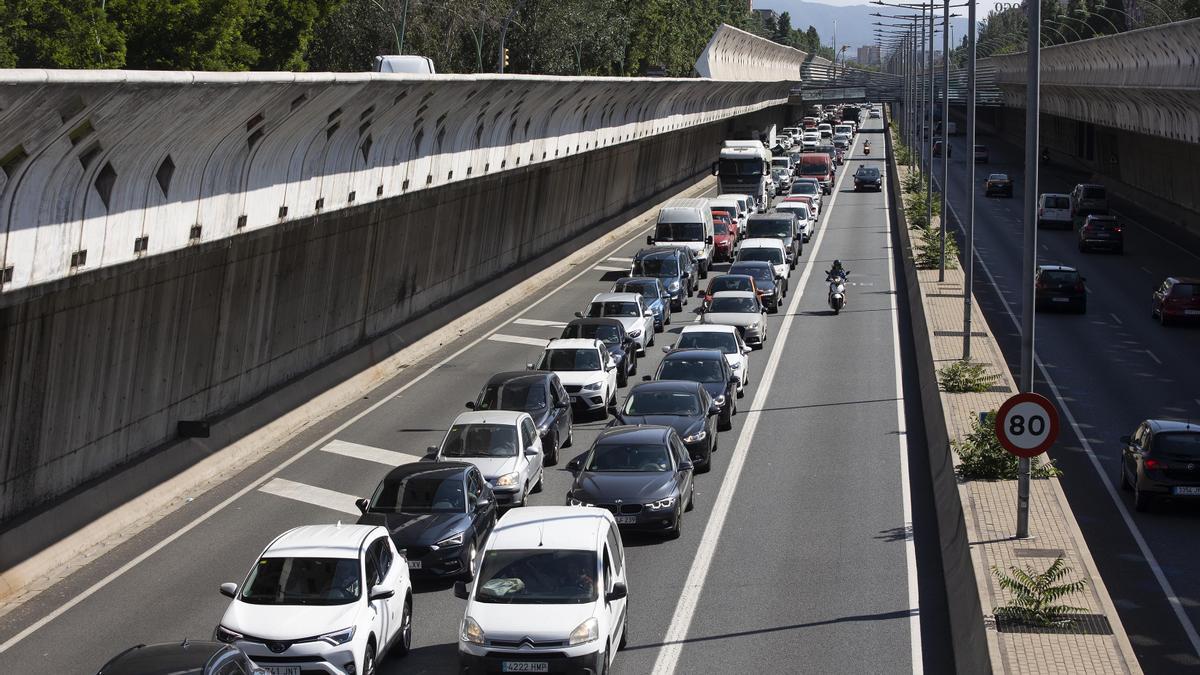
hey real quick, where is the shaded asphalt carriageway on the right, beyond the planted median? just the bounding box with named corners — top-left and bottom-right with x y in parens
top-left (935, 124), bottom-right (1200, 673)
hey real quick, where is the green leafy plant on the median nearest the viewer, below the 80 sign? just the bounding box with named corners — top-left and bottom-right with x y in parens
top-left (991, 556), bottom-right (1087, 626)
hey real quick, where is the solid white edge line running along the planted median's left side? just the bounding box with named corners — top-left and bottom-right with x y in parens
top-left (883, 153), bottom-right (925, 673)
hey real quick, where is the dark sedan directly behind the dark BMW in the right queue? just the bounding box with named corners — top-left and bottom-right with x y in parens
top-left (610, 380), bottom-right (721, 473)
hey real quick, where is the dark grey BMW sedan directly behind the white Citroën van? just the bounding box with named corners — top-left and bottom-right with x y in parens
top-left (566, 426), bottom-right (696, 538)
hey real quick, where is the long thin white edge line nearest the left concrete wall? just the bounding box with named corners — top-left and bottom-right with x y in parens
top-left (0, 193), bottom-right (672, 653)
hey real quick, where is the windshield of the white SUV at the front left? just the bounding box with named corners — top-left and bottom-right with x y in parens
top-left (241, 557), bottom-right (362, 605)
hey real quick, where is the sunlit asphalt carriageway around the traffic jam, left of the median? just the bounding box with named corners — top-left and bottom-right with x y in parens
top-left (0, 120), bottom-right (955, 675)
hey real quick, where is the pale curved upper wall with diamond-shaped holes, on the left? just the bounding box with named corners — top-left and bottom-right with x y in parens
top-left (0, 70), bottom-right (788, 291)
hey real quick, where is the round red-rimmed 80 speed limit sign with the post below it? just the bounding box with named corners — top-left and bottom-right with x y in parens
top-left (996, 392), bottom-right (1058, 539)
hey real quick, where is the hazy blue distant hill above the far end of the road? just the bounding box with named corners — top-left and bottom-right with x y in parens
top-left (754, 0), bottom-right (969, 58)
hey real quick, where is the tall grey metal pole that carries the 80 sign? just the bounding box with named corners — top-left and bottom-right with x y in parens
top-left (1016, 0), bottom-right (1042, 539)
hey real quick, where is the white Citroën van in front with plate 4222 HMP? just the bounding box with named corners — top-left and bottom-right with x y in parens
top-left (454, 506), bottom-right (629, 673)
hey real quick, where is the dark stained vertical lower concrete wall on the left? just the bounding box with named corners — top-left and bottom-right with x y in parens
top-left (0, 103), bottom-right (782, 521)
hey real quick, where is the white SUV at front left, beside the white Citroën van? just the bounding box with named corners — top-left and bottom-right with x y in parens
top-left (214, 524), bottom-right (413, 675)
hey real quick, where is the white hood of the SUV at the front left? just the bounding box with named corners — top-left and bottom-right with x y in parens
top-left (221, 601), bottom-right (361, 641)
